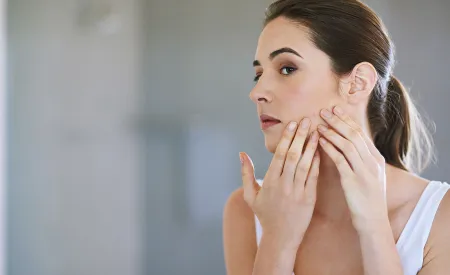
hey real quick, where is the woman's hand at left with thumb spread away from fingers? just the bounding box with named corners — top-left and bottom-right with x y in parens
top-left (240, 118), bottom-right (319, 250)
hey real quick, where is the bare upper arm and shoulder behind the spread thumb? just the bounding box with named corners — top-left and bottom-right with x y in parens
top-left (223, 188), bottom-right (257, 275)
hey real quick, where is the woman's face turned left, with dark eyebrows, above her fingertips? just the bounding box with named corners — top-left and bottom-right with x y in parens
top-left (250, 17), bottom-right (342, 153)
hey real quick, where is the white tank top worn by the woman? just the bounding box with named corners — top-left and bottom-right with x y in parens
top-left (255, 180), bottom-right (450, 275)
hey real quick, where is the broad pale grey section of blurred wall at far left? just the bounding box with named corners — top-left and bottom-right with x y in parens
top-left (8, 0), bottom-right (142, 275)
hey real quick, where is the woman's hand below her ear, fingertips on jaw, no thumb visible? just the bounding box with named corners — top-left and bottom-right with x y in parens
top-left (319, 107), bottom-right (388, 232)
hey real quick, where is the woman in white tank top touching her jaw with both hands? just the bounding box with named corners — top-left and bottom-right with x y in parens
top-left (224, 0), bottom-right (450, 275)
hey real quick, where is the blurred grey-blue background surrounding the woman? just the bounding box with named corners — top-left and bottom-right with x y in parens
top-left (0, 0), bottom-right (450, 275)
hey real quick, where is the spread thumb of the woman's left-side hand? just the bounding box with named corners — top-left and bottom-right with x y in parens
top-left (239, 152), bottom-right (260, 207)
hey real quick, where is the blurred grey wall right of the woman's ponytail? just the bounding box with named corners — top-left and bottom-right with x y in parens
top-left (386, 0), bottom-right (450, 181)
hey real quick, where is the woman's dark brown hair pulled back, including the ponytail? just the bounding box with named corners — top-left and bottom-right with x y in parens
top-left (264, 0), bottom-right (433, 173)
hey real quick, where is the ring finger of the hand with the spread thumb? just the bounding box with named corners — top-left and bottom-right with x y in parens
top-left (294, 131), bottom-right (319, 198)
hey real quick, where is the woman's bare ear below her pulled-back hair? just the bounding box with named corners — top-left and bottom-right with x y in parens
top-left (340, 62), bottom-right (378, 104)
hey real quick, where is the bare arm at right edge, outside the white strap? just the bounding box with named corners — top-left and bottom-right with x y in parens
top-left (418, 192), bottom-right (450, 275)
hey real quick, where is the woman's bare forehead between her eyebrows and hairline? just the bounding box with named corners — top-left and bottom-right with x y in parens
top-left (255, 17), bottom-right (314, 60)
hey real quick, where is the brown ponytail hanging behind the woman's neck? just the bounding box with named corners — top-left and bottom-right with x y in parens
top-left (374, 76), bottom-right (434, 173)
